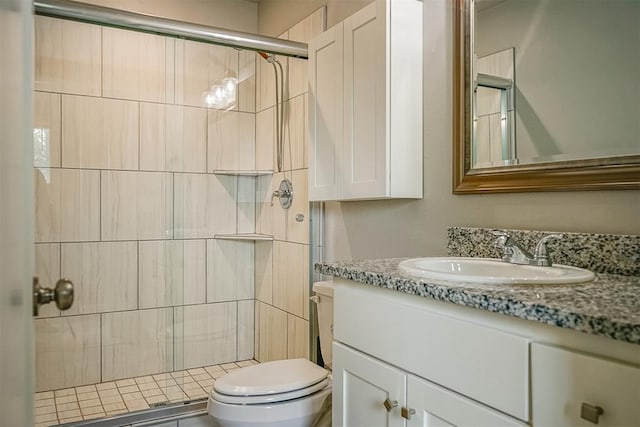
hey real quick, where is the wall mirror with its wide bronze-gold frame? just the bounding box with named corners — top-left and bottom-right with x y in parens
top-left (453, 0), bottom-right (640, 194)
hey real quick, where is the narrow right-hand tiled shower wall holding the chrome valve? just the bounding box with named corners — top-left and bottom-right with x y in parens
top-left (255, 9), bottom-right (325, 362)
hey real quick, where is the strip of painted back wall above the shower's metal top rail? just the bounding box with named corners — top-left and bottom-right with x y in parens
top-left (82, 0), bottom-right (258, 33)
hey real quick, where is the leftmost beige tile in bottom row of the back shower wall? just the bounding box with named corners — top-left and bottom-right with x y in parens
top-left (35, 315), bottom-right (100, 391)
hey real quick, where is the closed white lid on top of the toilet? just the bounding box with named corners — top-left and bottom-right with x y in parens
top-left (213, 359), bottom-right (329, 396)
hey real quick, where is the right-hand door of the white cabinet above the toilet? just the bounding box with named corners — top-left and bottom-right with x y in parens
top-left (342, 1), bottom-right (389, 199)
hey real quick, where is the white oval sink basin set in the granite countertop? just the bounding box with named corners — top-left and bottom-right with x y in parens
top-left (398, 257), bottom-right (595, 285)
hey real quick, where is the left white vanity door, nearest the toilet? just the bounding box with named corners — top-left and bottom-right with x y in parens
top-left (333, 342), bottom-right (406, 427)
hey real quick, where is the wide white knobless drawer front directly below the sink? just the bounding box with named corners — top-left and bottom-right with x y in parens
top-left (334, 282), bottom-right (529, 421)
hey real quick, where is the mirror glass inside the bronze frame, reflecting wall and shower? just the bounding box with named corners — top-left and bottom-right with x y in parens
top-left (471, 0), bottom-right (640, 168)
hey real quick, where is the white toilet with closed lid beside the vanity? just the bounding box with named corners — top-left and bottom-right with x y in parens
top-left (208, 282), bottom-right (333, 427)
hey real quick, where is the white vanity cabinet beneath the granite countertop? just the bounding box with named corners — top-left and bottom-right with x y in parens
top-left (333, 279), bottom-right (640, 427)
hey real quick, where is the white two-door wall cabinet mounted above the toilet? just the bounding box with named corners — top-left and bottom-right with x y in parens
top-left (308, 0), bottom-right (423, 201)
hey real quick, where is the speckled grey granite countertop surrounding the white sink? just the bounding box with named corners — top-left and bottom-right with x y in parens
top-left (315, 258), bottom-right (640, 345)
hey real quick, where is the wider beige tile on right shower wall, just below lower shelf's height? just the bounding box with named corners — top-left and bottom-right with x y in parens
top-left (273, 241), bottom-right (309, 317)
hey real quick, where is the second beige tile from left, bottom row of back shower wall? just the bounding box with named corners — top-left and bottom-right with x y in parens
top-left (102, 308), bottom-right (173, 381)
